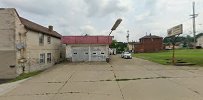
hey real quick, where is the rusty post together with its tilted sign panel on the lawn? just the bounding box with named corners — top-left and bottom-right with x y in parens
top-left (167, 24), bottom-right (183, 64)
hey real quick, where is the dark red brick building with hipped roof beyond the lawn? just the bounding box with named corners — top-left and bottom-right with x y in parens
top-left (134, 34), bottom-right (163, 52)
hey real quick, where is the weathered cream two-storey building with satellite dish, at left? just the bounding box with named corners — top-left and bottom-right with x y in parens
top-left (0, 8), bottom-right (61, 79)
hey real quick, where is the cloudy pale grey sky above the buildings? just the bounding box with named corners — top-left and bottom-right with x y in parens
top-left (0, 0), bottom-right (203, 42)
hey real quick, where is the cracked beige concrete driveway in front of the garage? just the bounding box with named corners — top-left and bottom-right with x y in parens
top-left (0, 55), bottom-right (203, 100)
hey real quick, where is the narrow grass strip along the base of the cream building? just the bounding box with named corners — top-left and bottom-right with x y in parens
top-left (9, 71), bottom-right (42, 82)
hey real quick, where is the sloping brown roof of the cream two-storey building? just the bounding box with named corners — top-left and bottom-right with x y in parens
top-left (19, 17), bottom-right (61, 38)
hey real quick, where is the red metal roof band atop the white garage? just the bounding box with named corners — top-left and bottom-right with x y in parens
top-left (61, 36), bottom-right (113, 44)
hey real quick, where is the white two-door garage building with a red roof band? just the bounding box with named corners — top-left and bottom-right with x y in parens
top-left (62, 36), bottom-right (112, 62)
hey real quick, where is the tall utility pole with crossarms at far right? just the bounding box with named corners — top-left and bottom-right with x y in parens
top-left (190, 1), bottom-right (198, 48)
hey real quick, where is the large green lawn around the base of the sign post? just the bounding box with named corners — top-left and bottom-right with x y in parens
top-left (133, 49), bottom-right (203, 66)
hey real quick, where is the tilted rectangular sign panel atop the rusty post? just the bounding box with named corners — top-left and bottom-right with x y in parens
top-left (167, 24), bottom-right (183, 37)
